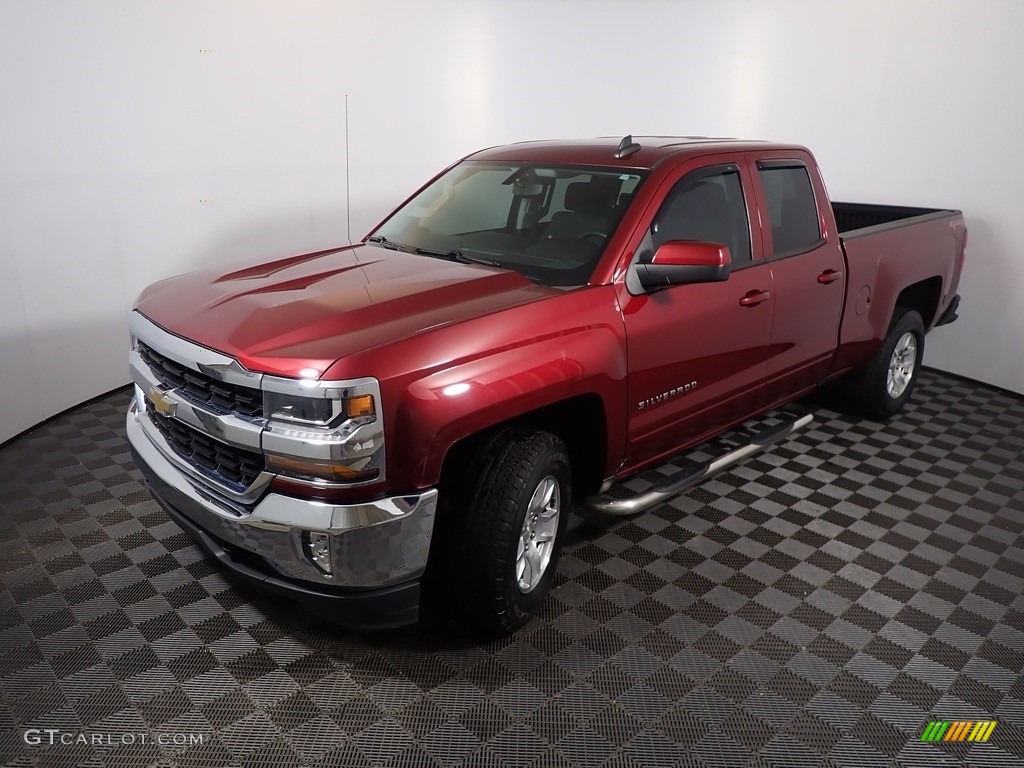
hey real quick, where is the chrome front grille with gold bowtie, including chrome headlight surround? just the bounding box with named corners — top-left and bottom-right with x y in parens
top-left (128, 311), bottom-right (385, 495)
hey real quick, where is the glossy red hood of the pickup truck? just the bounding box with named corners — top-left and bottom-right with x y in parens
top-left (135, 245), bottom-right (557, 377)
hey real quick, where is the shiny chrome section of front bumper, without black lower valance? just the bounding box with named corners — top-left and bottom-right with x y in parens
top-left (126, 401), bottom-right (437, 595)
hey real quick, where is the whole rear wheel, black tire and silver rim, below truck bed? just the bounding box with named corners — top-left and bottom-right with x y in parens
top-left (848, 307), bottom-right (925, 419)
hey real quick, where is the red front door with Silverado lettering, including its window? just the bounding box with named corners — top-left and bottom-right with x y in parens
top-left (618, 156), bottom-right (774, 466)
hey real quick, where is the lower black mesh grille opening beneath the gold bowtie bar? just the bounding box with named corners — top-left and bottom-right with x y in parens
top-left (145, 399), bottom-right (265, 492)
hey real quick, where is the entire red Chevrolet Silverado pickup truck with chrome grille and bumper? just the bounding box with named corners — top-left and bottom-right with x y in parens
top-left (127, 136), bottom-right (967, 633)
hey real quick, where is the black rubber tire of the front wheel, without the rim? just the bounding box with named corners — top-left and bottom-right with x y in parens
top-left (445, 429), bottom-right (571, 636)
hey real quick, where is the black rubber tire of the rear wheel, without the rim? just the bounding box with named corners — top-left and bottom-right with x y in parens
top-left (847, 307), bottom-right (925, 421)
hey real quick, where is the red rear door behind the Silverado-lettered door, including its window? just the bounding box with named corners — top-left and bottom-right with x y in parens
top-left (750, 150), bottom-right (846, 402)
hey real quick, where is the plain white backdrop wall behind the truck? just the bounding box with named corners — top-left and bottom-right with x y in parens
top-left (0, 0), bottom-right (1024, 441)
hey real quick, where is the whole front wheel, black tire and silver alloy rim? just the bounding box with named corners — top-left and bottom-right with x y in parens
top-left (453, 429), bottom-right (572, 635)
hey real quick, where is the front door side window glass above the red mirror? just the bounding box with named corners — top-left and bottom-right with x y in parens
top-left (650, 166), bottom-right (751, 265)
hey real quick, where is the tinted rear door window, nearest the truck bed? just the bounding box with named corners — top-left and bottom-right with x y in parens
top-left (758, 161), bottom-right (821, 256)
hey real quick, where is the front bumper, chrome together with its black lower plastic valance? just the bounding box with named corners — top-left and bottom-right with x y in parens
top-left (126, 403), bottom-right (437, 629)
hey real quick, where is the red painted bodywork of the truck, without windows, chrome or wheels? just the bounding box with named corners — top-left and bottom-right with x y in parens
top-left (137, 136), bottom-right (966, 494)
